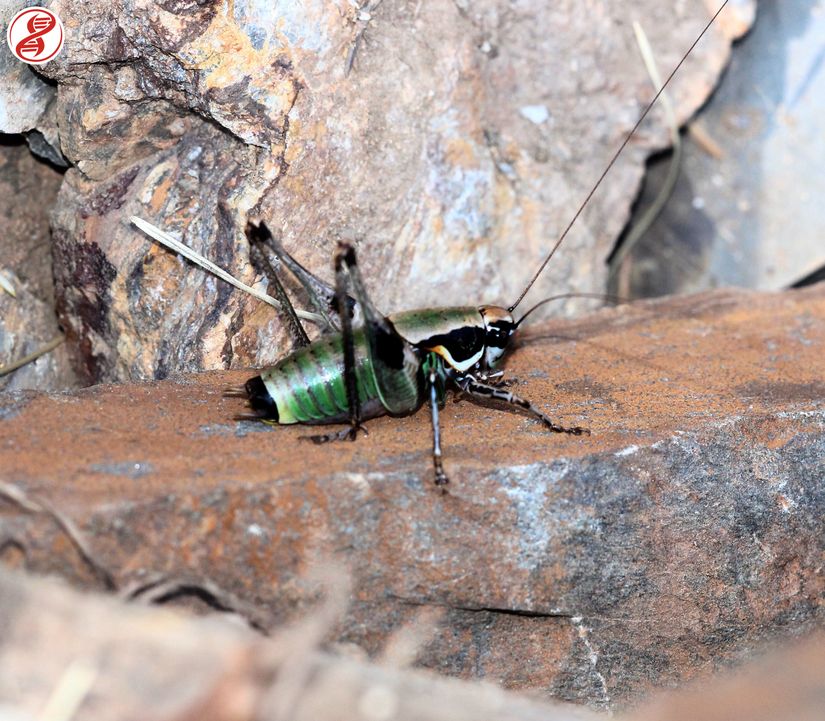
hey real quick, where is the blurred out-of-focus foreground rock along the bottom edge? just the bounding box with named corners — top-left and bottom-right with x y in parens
top-left (0, 573), bottom-right (825, 721)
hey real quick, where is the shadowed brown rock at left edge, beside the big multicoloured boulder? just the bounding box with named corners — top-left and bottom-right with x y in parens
top-left (0, 138), bottom-right (76, 390)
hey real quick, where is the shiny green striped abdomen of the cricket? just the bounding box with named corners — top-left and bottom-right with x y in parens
top-left (261, 329), bottom-right (386, 424)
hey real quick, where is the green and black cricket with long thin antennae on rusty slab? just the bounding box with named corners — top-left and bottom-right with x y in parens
top-left (131, 0), bottom-right (728, 492)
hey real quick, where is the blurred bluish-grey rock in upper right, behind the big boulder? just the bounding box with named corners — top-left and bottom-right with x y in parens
top-left (611, 3), bottom-right (825, 298)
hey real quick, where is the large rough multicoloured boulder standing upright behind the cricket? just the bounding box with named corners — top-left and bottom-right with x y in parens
top-left (25, 0), bottom-right (752, 383)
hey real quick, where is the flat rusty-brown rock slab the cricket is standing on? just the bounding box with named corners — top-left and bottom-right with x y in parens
top-left (0, 287), bottom-right (825, 707)
